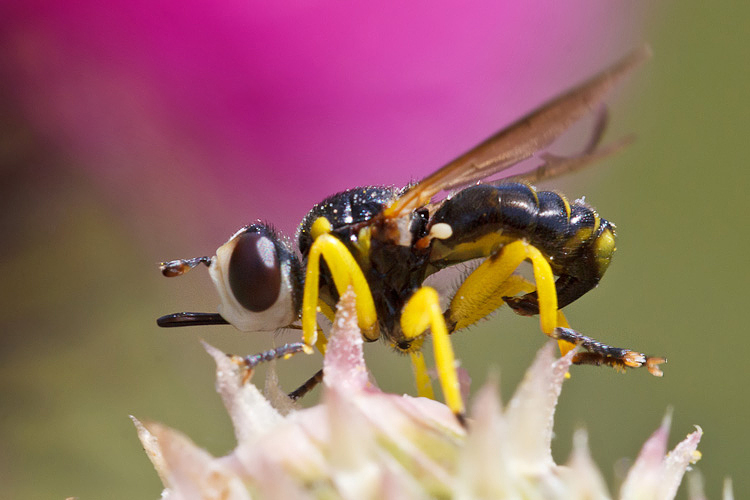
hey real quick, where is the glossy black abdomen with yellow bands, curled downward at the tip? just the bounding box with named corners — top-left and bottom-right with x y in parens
top-left (429, 183), bottom-right (615, 314)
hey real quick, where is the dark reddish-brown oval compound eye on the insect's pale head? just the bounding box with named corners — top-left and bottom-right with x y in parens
top-left (228, 233), bottom-right (281, 312)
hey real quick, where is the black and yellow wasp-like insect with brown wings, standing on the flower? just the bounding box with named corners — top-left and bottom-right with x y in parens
top-left (157, 48), bottom-right (666, 418)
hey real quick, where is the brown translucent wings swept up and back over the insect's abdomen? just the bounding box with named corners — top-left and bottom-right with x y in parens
top-left (384, 46), bottom-right (651, 217)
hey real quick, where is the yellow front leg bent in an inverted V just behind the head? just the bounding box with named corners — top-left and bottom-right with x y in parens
top-left (302, 227), bottom-right (378, 346)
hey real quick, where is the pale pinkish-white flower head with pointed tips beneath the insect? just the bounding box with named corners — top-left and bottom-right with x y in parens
top-left (133, 293), bottom-right (720, 500)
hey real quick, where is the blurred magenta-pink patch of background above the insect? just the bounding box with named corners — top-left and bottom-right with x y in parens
top-left (0, 0), bottom-right (629, 238)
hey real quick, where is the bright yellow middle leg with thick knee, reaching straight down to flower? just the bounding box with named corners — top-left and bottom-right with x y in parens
top-left (401, 287), bottom-right (464, 417)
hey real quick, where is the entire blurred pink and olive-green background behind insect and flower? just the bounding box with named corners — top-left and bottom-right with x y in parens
top-left (0, 0), bottom-right (750, 498)
